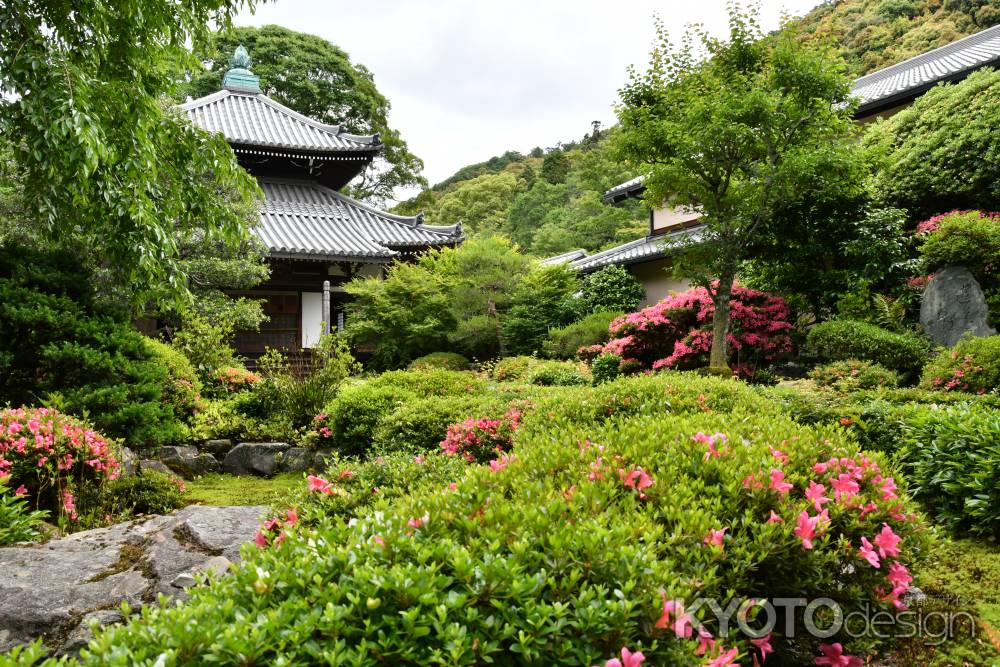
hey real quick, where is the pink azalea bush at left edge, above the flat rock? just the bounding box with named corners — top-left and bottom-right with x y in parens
top-left (0, 408), bottom-right (119, 521)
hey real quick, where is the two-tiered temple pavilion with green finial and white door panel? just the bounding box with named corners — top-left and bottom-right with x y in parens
top-left (180, 46), bottom-right (463, 359)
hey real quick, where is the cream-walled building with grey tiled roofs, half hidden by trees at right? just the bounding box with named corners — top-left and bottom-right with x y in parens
top-left (556, 25), bottom-right (1000, 305)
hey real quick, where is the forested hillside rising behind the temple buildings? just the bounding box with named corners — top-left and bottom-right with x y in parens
top-left (395, 0), bottom-right (1000, 256)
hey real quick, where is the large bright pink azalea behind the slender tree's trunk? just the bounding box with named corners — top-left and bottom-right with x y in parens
top-left (596, 286), bottom-right (792, 377)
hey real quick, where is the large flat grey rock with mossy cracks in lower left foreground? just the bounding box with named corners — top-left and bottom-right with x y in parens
top-left (0, 505), bottom-right (266, 653)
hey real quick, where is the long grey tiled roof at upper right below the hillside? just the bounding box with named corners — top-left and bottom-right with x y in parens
top-left (852, 25), bottom-right (1000, 116)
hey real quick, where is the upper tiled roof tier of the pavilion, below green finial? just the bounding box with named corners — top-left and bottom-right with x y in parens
top-left (180, 90), bottom-right (381, 153)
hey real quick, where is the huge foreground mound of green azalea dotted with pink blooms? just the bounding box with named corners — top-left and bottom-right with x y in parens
top-left (29, 373), bottom-right (927, 665)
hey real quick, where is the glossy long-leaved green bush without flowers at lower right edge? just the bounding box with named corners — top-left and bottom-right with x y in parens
top-left (899, 406), bottom-right (1000, 538)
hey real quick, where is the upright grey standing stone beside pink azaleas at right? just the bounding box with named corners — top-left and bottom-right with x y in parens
top-left (920, 266), bottom-right (996, 347)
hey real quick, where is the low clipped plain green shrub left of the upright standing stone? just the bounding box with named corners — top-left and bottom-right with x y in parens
top-left (807, 320), bottom-right (931, 378)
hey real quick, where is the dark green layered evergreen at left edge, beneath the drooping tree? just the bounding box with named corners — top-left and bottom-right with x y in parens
top-left (0, 244), bottom-right (184, 447)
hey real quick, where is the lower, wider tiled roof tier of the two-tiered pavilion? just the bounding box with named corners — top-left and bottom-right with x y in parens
top-left (254, 177), bottom-right (463, 262)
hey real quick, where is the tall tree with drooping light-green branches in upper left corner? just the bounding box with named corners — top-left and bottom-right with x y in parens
top-left (0, 0), bottom-right (257, 301)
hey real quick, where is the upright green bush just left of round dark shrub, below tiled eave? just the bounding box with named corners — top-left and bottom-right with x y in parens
top-left (502, 265), bottom-right (580, 355)
